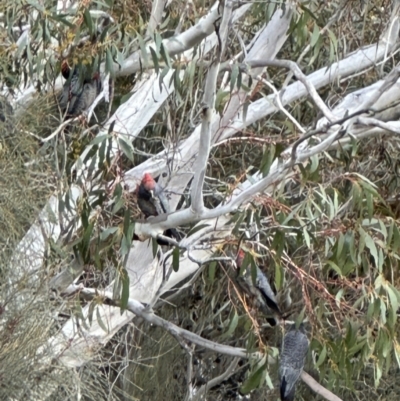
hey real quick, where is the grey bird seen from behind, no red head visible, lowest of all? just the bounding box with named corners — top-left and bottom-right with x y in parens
top-left (279, 324), bottom-right (309, 401)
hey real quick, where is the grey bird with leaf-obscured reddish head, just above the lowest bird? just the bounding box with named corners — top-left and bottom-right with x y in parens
top-left (236, 249), bottom-right (282, 324)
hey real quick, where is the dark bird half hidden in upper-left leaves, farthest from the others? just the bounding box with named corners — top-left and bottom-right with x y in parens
top-left (58, 60), bottom-right (101, 117)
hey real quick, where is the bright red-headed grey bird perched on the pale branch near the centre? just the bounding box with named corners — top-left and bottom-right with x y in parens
top-left (136, 173), bottom-right (181, 245)
